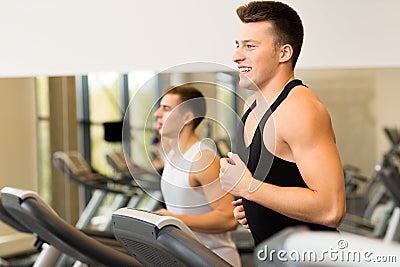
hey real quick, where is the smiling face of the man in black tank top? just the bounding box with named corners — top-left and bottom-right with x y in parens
top-left (233, 21), bottom-right (279, 90)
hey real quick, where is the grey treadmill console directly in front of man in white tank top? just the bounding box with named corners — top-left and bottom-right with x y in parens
top-left (112, 208), bottom-right (231, 267)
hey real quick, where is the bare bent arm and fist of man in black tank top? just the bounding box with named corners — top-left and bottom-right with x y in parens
top-left (220, 89), bottom-right (345, 227)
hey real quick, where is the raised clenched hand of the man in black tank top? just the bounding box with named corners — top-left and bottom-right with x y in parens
top-left (219, 152), bottom-right (255, 197)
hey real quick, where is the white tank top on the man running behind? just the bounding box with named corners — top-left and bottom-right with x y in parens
top-left (161, 142), bottom-right (240, 266)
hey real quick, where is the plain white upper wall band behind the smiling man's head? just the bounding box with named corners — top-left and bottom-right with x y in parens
top-left (0, 0), bottom-right (400, 77)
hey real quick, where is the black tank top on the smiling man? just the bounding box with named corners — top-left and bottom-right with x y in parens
top-left (236, 80), bottom-right (336, 245)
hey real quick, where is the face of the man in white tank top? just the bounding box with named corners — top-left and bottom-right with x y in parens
top-left (154, 94), bottom-right (185, 138)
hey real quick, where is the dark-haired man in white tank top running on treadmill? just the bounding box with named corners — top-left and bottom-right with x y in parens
top-left (154, 84), bottom-right (241, 267)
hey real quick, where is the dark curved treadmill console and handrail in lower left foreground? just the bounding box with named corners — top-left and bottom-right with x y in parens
top-left (2, 190), bottom-right (142, 266)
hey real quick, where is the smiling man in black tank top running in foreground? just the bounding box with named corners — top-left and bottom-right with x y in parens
top-left (220, 1), bottom-right (346, 245)
